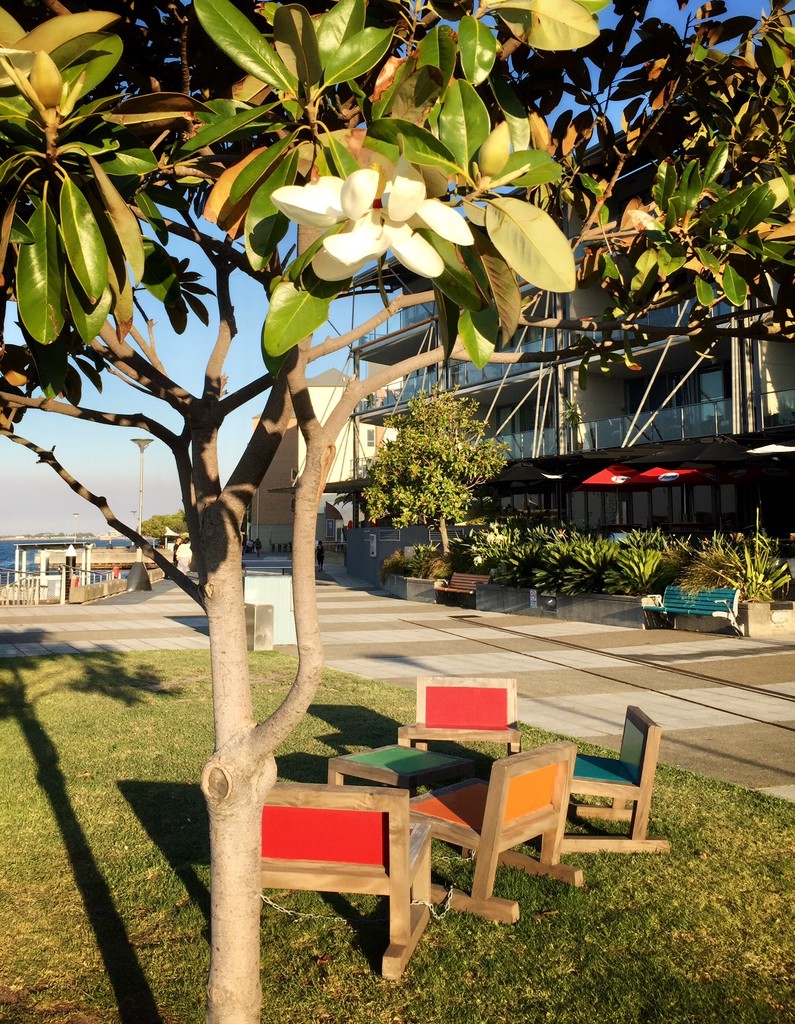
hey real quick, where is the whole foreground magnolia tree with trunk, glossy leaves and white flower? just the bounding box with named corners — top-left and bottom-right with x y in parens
top-left (0, 0), bottom-right (795, 1024)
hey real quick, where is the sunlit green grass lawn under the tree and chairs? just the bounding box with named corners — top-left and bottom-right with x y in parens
top-left (0, 651), bottom-right (795, 1024)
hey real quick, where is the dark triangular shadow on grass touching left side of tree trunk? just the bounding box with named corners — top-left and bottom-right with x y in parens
top-left (118, 778), bottom-right (210, 935)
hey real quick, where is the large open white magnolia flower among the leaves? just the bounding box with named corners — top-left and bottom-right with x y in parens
top-left (270, 157), bottom-right (474, 281)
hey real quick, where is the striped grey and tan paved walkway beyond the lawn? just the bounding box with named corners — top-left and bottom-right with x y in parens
top-left (0, 558), bottom-right (795, 800)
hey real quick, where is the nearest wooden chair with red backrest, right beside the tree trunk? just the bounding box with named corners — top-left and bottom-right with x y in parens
top-left (261, 782), bottom-right (430, 979)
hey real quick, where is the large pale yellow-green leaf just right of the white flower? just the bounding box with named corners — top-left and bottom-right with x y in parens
top-left (486, 198), bottom-right (577, 292)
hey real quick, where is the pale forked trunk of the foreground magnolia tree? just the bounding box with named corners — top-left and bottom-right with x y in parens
top-left (202, 337), bottom-right (335, 1024)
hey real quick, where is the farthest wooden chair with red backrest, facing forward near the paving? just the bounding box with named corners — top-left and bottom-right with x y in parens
top-left (398, 676), bottom-right (521, 754)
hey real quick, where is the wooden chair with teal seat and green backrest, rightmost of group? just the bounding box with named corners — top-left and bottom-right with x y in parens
top-left (561, 707), bottom-right (671, 853)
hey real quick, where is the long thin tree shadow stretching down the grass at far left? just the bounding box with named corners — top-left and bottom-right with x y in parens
top-left (0, 647), bottom-right (177, 1024)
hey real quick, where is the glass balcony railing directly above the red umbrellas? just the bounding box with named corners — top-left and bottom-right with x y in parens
top-left (582, 392), bottom-right (729, 451)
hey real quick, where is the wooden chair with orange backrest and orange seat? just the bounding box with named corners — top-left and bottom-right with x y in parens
top-left (411, 743), bottom-right (583, 924)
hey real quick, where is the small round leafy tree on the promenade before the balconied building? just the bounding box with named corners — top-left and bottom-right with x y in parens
top-left (364, 389), bottom-right (507, 554)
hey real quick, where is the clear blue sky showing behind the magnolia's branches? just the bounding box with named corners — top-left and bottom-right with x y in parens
top-left (0, 0), bottom-right (769, 535)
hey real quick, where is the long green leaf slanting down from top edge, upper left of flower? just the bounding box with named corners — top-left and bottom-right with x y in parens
top-left (194, 0), bottom-right (298, 94)
